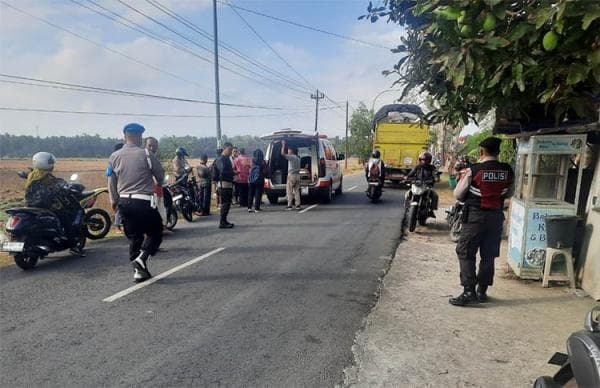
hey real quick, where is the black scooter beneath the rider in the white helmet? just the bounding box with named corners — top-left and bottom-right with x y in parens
top-left (0, 172), bottom-right (86, 270)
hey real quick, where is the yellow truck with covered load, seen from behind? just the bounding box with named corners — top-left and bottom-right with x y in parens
top-left (373, 104), bottom-right (429, 183)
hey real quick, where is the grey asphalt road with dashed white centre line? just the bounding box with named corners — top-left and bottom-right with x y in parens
top-left (0, 176), bottom-right (403, 387)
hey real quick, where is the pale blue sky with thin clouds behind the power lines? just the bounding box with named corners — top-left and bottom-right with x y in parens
top-left (0, 0), bottom-right (402, 137)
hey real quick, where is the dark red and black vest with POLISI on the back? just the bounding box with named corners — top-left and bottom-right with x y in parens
top-left (465, 160), bottom-right (514, 209)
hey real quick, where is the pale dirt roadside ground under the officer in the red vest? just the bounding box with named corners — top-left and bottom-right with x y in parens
top-left (343, 177), bottom-right (597, 387)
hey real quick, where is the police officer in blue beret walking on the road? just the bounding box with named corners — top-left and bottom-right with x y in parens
top-left (108, 123), bottom-right (165, 283)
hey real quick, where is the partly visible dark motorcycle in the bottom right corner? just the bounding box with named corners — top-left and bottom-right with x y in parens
top-left (533, 306), bottom-right (600, 388)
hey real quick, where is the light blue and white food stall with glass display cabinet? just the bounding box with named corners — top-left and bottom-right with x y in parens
top-left (508, 135), bottom-right (586, 279)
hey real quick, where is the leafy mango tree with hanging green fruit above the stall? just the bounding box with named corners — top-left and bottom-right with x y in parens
top-left (360, 0), bottom-right (600, 125)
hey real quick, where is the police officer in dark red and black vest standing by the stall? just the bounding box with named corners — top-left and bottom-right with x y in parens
top-left (449, 137), bottom-right (514, 306)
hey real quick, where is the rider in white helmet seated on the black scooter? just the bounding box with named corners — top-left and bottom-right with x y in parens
top-left (25, 152), bottom-right (83, 255)
